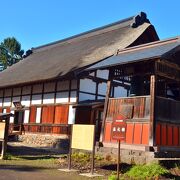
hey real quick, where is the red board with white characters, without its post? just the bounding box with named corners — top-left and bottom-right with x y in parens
top-left (112, 116), bottom-right (127, 140)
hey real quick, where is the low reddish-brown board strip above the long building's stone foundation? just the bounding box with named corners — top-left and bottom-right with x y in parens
top-left (23, 123), bottom-right (70, 135)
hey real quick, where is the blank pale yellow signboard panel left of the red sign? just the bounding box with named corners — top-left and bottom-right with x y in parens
top-left (71, 124), bottom-right (95, 151)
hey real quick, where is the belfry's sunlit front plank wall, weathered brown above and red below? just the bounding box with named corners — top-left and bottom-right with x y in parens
top-left (104, 96), bottom-right (150, 145)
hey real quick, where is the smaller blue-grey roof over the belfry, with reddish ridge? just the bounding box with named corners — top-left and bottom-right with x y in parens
top-left (87, 37), bottom-right (180, 70)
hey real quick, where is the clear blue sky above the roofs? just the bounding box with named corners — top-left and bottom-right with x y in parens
top-left (0, 0), bottom-right (180, 50)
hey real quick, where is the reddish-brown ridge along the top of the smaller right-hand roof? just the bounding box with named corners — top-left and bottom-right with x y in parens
top-left (116, 36), bottom-right (180, 55)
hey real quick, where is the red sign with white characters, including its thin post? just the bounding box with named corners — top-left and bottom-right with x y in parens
top-left (112, 116), bottom-right (127, 180)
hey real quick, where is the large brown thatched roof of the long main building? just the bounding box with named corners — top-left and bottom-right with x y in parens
top-left (0, 13), bottom-right (158, 87)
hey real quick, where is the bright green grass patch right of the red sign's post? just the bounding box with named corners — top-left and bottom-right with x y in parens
top-left (124, 163), bottom-right (169, 179)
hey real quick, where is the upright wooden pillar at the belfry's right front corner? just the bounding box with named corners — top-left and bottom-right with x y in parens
top-left (149, 75), bottom-right (156, 146)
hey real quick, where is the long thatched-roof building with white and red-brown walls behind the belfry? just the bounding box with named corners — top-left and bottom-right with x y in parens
top-left (0, 12), bottom-right (159, 145)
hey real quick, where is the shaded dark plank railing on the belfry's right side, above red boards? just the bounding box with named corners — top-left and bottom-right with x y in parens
top-left (155, 97), bottom-right (180, 123)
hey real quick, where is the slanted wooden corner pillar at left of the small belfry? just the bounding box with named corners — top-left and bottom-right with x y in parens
top-left (100, 80), bottom-right (112, 142)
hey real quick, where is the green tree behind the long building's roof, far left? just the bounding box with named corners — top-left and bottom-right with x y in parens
top-left (0, 37), bottom-right (24, 70)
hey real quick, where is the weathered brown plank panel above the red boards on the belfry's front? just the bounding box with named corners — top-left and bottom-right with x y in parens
top-left (107, 96), bottom-right (150, 120)
